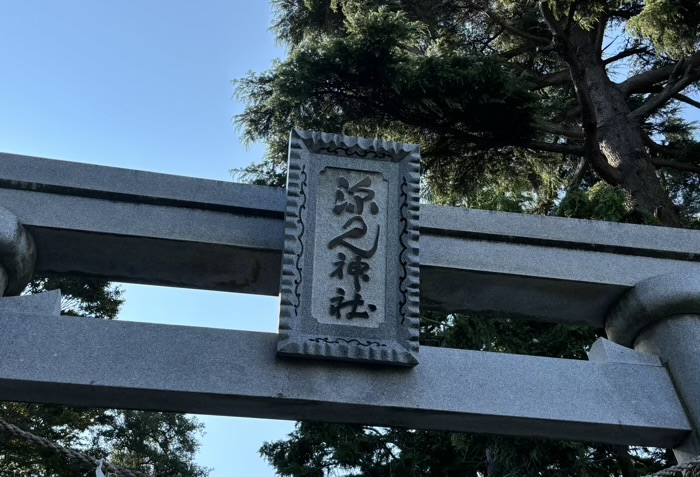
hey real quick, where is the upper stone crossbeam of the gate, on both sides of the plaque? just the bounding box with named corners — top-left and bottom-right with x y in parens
top-left (0, 154), bottom-right (700, 327)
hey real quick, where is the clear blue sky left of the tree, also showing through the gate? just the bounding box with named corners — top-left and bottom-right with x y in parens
top-left (0, 0), bottom-right (293, 477)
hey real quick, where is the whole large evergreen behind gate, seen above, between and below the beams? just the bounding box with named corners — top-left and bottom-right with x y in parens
top-left (235, 0), bottom-right (700, 477)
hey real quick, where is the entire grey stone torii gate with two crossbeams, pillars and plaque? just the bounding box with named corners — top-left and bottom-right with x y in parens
top-left (0, 133), bottom-right (700, 461)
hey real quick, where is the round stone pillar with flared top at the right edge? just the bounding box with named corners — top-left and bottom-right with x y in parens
top-left (605, 274), bottom-right (700, 463)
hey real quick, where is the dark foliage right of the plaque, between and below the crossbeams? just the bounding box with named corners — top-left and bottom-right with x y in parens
top-left (260, 313), bottom-right (672, 477)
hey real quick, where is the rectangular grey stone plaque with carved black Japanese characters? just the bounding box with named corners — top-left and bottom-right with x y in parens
top-left (277, 130), bottom-right (420, 366)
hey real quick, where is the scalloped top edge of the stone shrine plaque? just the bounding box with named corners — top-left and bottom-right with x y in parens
top-left (292, 129), bottom-right (418, 162)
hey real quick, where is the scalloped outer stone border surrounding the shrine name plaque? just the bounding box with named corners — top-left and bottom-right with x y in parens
top-left (277, 129), bottom-right (420, 366)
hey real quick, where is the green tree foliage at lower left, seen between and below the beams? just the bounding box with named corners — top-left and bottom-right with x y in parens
top-left (0, 277), bottom-right (208, 477)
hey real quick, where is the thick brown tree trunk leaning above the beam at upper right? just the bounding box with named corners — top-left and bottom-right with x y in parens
top-left (545, 15), bottom-right (680, 227)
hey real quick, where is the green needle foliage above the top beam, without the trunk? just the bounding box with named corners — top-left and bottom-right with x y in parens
top-left (234, 0), bottom-right (700, 226)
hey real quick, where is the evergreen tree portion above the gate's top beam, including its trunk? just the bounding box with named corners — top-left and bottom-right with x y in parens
top-left (236, 0), bottom-right (700, 226)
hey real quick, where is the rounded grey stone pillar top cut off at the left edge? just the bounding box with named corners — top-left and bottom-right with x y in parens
top-left (0, 207), bottom-right (36, 296)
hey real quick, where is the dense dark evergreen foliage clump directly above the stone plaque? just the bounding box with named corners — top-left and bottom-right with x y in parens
top-left (235, 2), bottom-right (532, 190)
